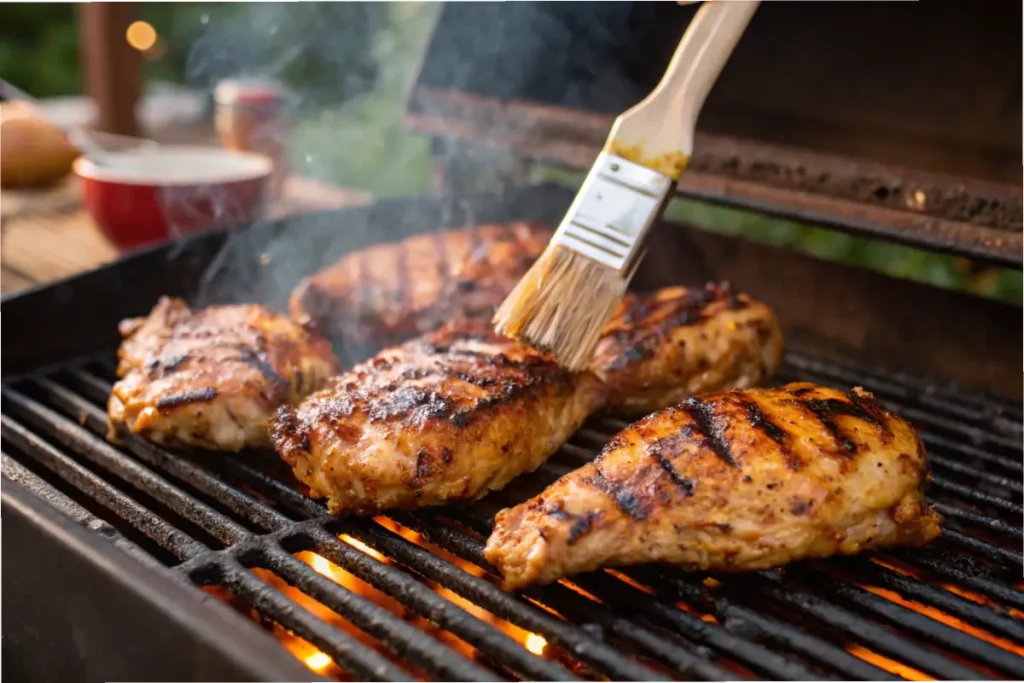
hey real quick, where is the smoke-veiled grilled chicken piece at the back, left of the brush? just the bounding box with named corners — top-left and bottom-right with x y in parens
top-left (290, 222), bottom-right (551, 347)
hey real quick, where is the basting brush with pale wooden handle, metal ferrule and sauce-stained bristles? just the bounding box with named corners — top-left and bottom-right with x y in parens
top-left (494, 0), bottom-right (760, 371)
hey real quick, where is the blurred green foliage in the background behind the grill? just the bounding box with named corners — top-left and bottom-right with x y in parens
top-left (0, 0), bottom-right (1024, 303)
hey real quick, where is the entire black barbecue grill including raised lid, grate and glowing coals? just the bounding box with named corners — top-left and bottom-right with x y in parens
top-left (6, 0), bottom-right (1024, 671)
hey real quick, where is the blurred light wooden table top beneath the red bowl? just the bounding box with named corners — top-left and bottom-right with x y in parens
top-left (0, 176), bottom-right (373, 298)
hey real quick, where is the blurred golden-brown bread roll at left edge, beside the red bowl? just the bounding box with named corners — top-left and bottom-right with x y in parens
top-left (0, 102), bottom-right (79, 187)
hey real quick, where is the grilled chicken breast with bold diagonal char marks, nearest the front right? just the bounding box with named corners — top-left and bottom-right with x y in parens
top-left (484, 383), bottom-right (940, 588)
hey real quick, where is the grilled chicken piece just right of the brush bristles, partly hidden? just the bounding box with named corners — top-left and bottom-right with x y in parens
top-left (591, 284), bottom-right (782, 415)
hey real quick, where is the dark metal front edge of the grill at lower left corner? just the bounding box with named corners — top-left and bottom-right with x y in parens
top-left (0, 463), bottom-right (323, 683)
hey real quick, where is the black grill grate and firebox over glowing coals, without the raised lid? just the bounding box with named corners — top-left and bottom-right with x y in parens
top-left (0, 179), bottom-right (1024, 683)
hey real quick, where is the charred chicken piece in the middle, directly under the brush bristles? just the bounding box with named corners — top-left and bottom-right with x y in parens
top-left (271, 321), bottom-right (604, 514)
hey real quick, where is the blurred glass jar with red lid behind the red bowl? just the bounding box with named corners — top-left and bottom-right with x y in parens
top-left (213, 80), bottom-right (292, 197)
